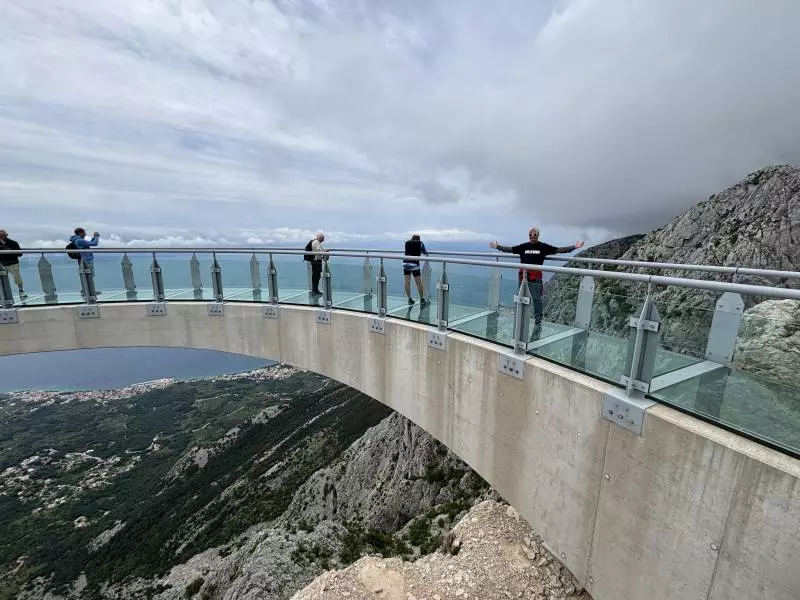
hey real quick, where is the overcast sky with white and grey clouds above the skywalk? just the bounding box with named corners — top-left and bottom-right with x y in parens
top-left (0, 0), bottom-right (800, 245)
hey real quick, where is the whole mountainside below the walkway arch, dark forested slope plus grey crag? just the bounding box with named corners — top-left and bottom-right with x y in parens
top-left (6, 365), bottom-right (491, 600)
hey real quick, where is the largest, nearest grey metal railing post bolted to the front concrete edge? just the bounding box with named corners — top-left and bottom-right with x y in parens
top-left (622, 283), bottom-right (661, 398)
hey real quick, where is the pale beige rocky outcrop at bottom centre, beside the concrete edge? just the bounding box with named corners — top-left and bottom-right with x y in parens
top-left (292, 500), bottom-right (590, 600)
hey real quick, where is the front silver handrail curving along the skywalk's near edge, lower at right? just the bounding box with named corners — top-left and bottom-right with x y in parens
top-left (0, 247), bottom-right (800, 300)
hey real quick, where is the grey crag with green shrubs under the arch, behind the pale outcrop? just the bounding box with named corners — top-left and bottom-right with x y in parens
top-left (136, 413), bottom-right (492, 600)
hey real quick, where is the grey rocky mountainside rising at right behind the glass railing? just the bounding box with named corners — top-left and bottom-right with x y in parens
top-left (546, 166), bottom-right (800, 355)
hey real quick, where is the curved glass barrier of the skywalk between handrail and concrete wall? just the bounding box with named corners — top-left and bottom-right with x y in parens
top-left (0, 249), bottom-right (800, 456)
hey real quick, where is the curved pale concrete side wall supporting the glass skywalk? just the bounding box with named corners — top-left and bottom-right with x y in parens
top-left (0, 303), bottom-right (800, 600)
